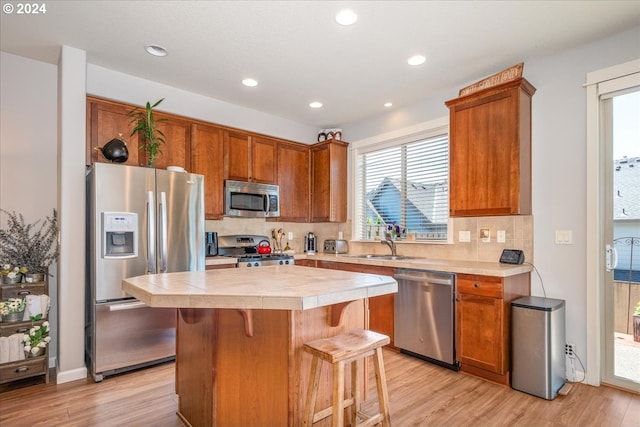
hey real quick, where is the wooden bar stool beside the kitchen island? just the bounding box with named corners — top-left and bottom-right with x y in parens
top-left (303, 329), bottom-right (391, 427)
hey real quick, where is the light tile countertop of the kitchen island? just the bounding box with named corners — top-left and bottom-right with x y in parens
top-left (122, 266), bottom-right (398, 310)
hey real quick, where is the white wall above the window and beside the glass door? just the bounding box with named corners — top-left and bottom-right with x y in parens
top-left (342, 26), bottom-right (640, 380)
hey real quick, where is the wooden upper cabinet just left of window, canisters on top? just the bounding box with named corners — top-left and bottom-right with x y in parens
top-left (310, 140), bottom-right (349, 222)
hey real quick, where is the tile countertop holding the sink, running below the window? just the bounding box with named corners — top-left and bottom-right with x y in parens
top-left (295, 254), bottom-right (533, 277)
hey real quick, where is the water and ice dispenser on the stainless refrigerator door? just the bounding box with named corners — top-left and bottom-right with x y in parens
top-left (102, 212), bottom-right (138, 259)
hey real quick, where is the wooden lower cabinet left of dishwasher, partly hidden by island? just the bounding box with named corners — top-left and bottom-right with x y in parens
top-left (317, 261), bottom-right (395, 348)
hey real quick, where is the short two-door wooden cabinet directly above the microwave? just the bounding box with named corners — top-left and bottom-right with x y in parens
top-left (224, 130), bottom-right (278, 184)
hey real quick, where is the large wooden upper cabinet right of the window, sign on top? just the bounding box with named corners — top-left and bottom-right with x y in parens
top-left (446, 78), bottom-right (536, 217)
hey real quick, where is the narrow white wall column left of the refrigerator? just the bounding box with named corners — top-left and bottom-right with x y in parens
top-left (57, 46), bottom-right (87, 384)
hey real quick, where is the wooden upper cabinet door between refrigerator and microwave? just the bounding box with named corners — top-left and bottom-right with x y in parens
top-left (191, 124), bottom-right (224, 219)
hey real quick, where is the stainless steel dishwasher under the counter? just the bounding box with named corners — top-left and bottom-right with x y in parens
top-left (394, 268), bottom-right (460, 371)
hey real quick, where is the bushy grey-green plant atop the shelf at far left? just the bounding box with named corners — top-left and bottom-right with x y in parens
top-left (0, 209), bottom-right (60, 276)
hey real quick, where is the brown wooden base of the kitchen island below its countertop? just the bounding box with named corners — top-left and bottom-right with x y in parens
top-left (176, 300), bottom-right (367, 427)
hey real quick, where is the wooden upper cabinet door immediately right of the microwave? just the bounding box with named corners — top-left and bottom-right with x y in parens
top-left (274, 142), bottom-right (310, 222)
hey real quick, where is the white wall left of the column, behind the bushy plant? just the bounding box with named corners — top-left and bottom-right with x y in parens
top-left (0, 52), bottom-right (58, 366)
